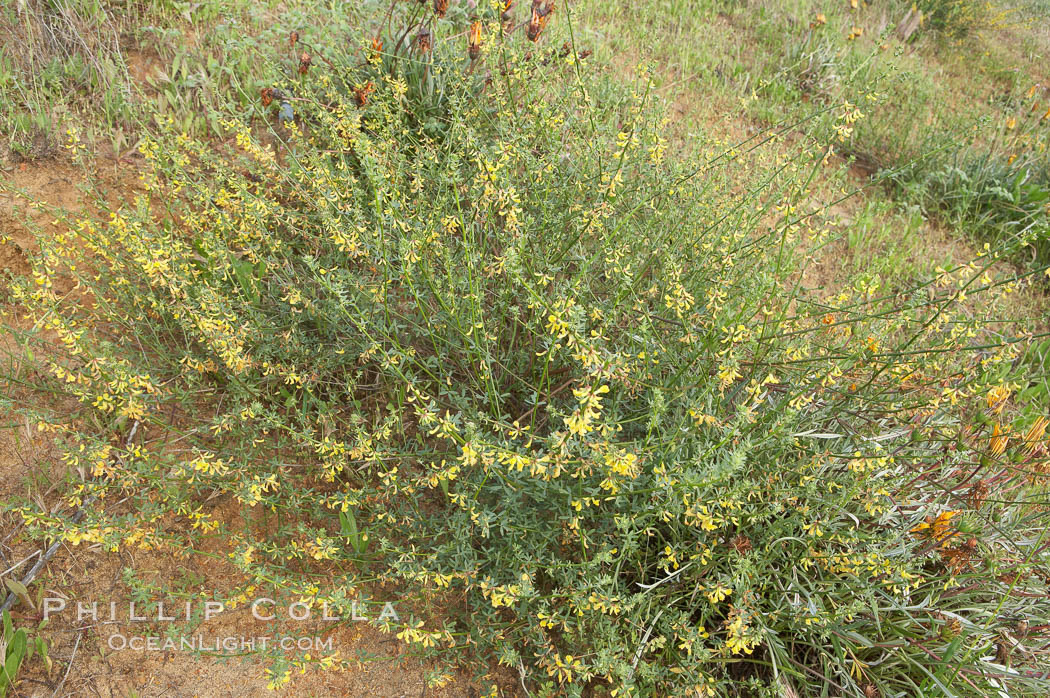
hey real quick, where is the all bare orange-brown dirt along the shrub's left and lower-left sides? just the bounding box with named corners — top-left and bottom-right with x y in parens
top-left (0, 161), bottom-right (499, 698)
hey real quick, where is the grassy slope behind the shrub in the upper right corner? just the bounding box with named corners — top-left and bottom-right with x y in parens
top-left (585, 0), bottom-right (1050, 268)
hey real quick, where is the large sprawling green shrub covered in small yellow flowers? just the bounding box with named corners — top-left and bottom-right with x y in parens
top-left (4, 2), bottom-right (1050, 696)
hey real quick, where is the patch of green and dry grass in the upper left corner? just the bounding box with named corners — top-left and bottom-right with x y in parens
top-left (0, 0), bottom-right (380, 160)
